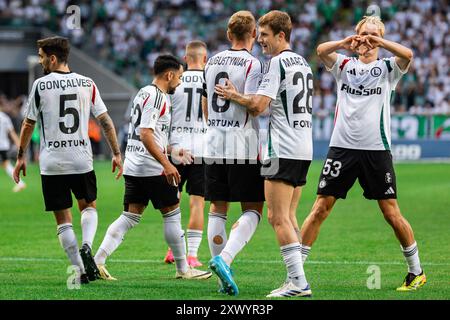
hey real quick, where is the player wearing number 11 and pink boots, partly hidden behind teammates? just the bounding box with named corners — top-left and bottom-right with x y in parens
top-left (164, 40), bottom-right (207, 267)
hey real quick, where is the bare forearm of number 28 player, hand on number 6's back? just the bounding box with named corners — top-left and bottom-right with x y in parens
top-left (214, 80), bottom-right (272, 116)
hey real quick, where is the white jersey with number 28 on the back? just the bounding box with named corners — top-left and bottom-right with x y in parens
top-left (257, 50), bottom-right (313, 161)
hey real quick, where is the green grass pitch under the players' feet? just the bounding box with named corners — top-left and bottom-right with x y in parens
top-left (0, 162), bottom-right (450, 300)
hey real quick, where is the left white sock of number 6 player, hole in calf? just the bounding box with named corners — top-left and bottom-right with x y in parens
top-left (208, 212), bottom-right (227, 257)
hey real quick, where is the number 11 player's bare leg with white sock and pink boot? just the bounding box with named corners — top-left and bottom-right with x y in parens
top-left (187, 195), bottom-right (205, 267)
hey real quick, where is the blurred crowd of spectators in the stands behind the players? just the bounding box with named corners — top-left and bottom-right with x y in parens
top-left (0, 0), bottom-right (450, 122)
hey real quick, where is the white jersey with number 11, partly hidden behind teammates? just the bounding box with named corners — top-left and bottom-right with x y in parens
top-left (169, 70), bottom-right (206, 158)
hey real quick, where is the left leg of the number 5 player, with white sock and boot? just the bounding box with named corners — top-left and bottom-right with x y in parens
top-left (54, 208), bottom-right (89, 284)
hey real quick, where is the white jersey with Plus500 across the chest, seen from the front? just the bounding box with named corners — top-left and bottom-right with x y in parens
top-left (328, 54), bottom-right (409, 150)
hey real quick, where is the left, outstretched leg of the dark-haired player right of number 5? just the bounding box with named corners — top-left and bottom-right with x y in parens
top-left (94, 203), bottom-right (146, 280)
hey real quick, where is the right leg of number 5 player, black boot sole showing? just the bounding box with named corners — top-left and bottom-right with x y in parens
top-left (78, 199), bottom-right (100, 281)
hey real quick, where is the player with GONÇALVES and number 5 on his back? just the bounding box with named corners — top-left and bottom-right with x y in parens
top-left (14, 37), bottom-right (122, 283)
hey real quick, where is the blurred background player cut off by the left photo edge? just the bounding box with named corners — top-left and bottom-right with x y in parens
top-left (0, 110), bottom-right (27, 192)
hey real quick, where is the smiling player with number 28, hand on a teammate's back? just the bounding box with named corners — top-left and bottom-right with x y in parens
top-left (216, 10), bottom-right (313, 298)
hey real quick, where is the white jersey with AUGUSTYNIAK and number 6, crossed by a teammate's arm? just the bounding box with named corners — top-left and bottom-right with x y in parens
top-left (204, 49), bottom-right (262, 160)
